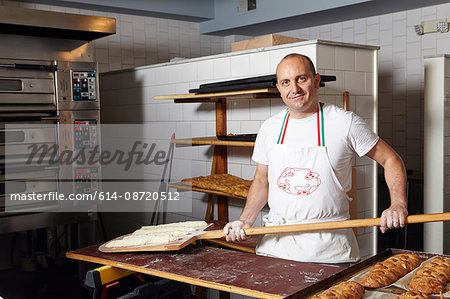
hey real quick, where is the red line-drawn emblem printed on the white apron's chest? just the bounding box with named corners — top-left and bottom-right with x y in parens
top-left (277, 167), bottom-right (320, 195)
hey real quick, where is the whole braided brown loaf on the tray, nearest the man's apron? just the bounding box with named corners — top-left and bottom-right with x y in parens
top-left (361, 253), bottom-right (422, 288)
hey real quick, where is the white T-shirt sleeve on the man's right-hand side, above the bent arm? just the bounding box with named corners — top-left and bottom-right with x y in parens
top-left (349, 113), bottom-right (380, 157)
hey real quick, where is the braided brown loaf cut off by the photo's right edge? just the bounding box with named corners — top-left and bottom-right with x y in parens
top-left (409, 256), bottom-right (450, 294)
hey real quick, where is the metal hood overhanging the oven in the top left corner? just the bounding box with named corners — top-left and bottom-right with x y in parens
top-left (0, 6), bottom-right (116, 41)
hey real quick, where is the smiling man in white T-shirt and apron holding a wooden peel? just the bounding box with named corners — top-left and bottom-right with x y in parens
top-left (224, 53), bottom-right (408, 263)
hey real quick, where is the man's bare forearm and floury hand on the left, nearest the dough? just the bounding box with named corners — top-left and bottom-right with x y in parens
top-left (224, 163), bottom-right (269, 241)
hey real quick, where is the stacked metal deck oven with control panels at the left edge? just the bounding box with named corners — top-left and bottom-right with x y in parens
top-left (0, 58), bottom-right (101, 233)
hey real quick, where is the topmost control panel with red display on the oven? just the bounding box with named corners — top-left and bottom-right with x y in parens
top-left (72, 71), bottom-right (97, 101)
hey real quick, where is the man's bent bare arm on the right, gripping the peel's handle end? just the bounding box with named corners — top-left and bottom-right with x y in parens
top-left (366, 139), bottom-right (408, 233)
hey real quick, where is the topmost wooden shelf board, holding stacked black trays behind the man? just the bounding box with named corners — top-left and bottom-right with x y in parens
top-left (153, 88), bottom-right (279, 103)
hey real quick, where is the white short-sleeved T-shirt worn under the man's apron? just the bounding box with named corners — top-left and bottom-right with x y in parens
top-left (252, 104), bottom-right (379, 191)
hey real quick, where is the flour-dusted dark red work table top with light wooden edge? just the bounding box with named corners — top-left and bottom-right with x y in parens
top-left (66, 245), bottom-right (345, 298)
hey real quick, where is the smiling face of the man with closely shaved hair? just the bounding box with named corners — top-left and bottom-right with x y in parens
top-left (277, 57), bottom-right (320, 118)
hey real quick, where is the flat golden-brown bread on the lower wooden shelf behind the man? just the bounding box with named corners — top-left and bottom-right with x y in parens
top-left (181, 173), bottom-right (252, 197)
